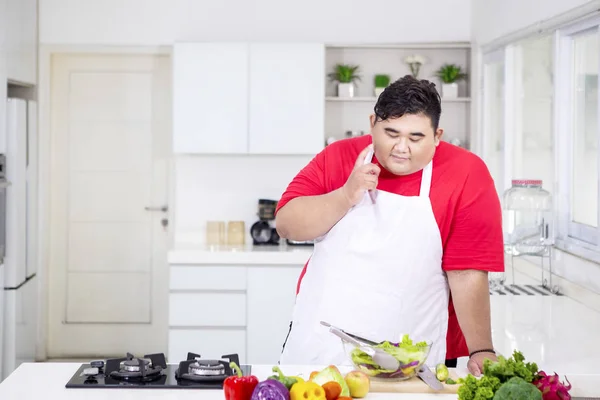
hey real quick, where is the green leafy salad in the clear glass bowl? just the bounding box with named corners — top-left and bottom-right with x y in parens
top-left (350, 335), bottom-right (430, 378)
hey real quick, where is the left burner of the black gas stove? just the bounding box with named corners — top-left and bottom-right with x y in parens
top-left (106, 353), bottom-right (167, 382)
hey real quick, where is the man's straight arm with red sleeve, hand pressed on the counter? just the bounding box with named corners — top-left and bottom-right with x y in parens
top-left (442, 158), bottom-right (504, 375)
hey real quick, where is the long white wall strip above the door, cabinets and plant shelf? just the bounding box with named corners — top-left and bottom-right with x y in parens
top-left (40, 0), bottom-right (471, 45)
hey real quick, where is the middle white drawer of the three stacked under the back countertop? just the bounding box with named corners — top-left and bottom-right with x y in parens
top-left (169, 293), bottom-right (246, 327)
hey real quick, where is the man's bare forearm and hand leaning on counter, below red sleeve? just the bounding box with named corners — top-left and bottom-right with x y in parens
top-left (448, 270), bottom-right (496, 376)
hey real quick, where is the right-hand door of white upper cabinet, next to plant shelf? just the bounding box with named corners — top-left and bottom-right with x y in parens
top-left (248, 43), bottom-right (325, 155)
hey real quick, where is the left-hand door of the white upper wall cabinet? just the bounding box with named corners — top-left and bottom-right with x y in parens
top-left (173, 43), bottom-right (248, 154)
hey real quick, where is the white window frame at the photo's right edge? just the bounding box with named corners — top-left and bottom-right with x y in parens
top-left (554, 16), bottom-right (600, 262)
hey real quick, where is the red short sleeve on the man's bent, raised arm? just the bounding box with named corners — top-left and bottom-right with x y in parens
top-left (275, 150), bottom-right (327, 212)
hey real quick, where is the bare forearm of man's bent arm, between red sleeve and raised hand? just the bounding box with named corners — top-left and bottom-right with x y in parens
top-left (275, 188), bottom-right (351, 241)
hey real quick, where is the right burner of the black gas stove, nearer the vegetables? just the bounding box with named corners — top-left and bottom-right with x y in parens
top-left (175, 353), bottom-right (240, 382)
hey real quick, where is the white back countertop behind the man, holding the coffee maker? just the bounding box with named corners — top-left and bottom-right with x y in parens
top-left (168, 243), bottom-right (313, 266)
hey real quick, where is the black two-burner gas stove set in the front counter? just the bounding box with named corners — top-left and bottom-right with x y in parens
top-left (65, 353), bottom-right (251, 389)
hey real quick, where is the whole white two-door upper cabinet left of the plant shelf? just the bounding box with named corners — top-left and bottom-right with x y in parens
top-left (173, 43), bottom-right (325, 155)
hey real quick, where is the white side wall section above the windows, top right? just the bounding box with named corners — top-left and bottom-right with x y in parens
top-left (471, 0), bottom-right (591, 45)
